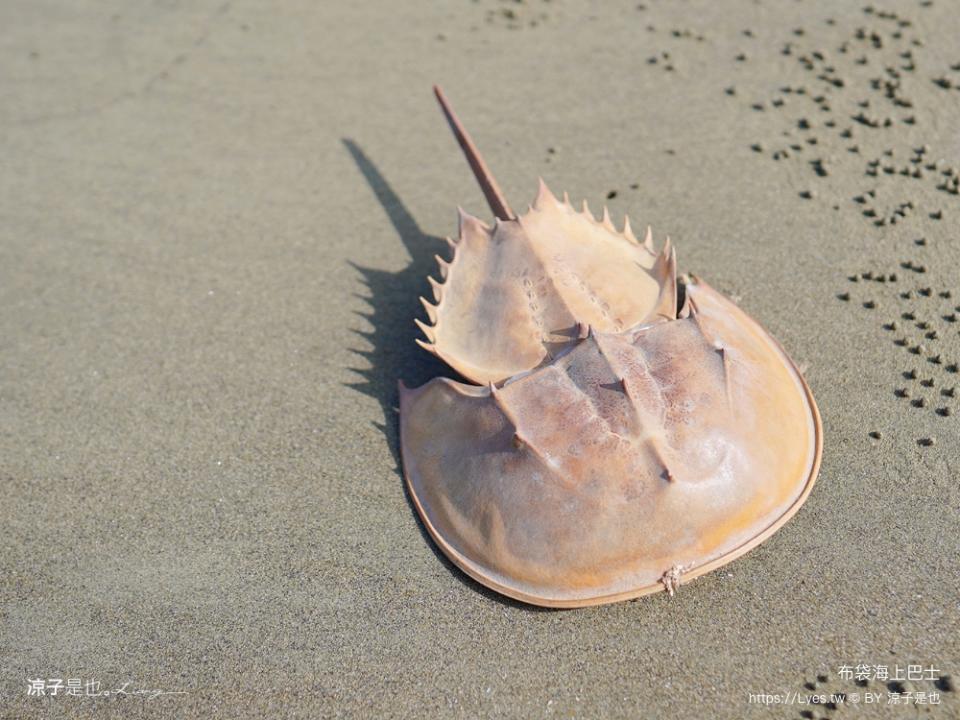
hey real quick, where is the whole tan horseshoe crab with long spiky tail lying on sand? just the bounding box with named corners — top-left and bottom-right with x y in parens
top-left (400, 89), bottom-right (822, 607)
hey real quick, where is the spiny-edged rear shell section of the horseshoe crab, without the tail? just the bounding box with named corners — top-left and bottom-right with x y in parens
top-left (417, 180), bottom-right (677, 383)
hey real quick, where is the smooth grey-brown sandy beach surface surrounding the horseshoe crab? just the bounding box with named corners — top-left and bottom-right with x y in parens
top-left (0, 0), bottom-right (960, 719)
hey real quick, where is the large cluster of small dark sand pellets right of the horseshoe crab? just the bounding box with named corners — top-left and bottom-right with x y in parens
top-left (725, 3), bottom-right (960, 447)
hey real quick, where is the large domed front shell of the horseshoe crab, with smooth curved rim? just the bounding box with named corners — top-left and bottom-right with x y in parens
top-left (400, 281), bottom-right (822, 607)
